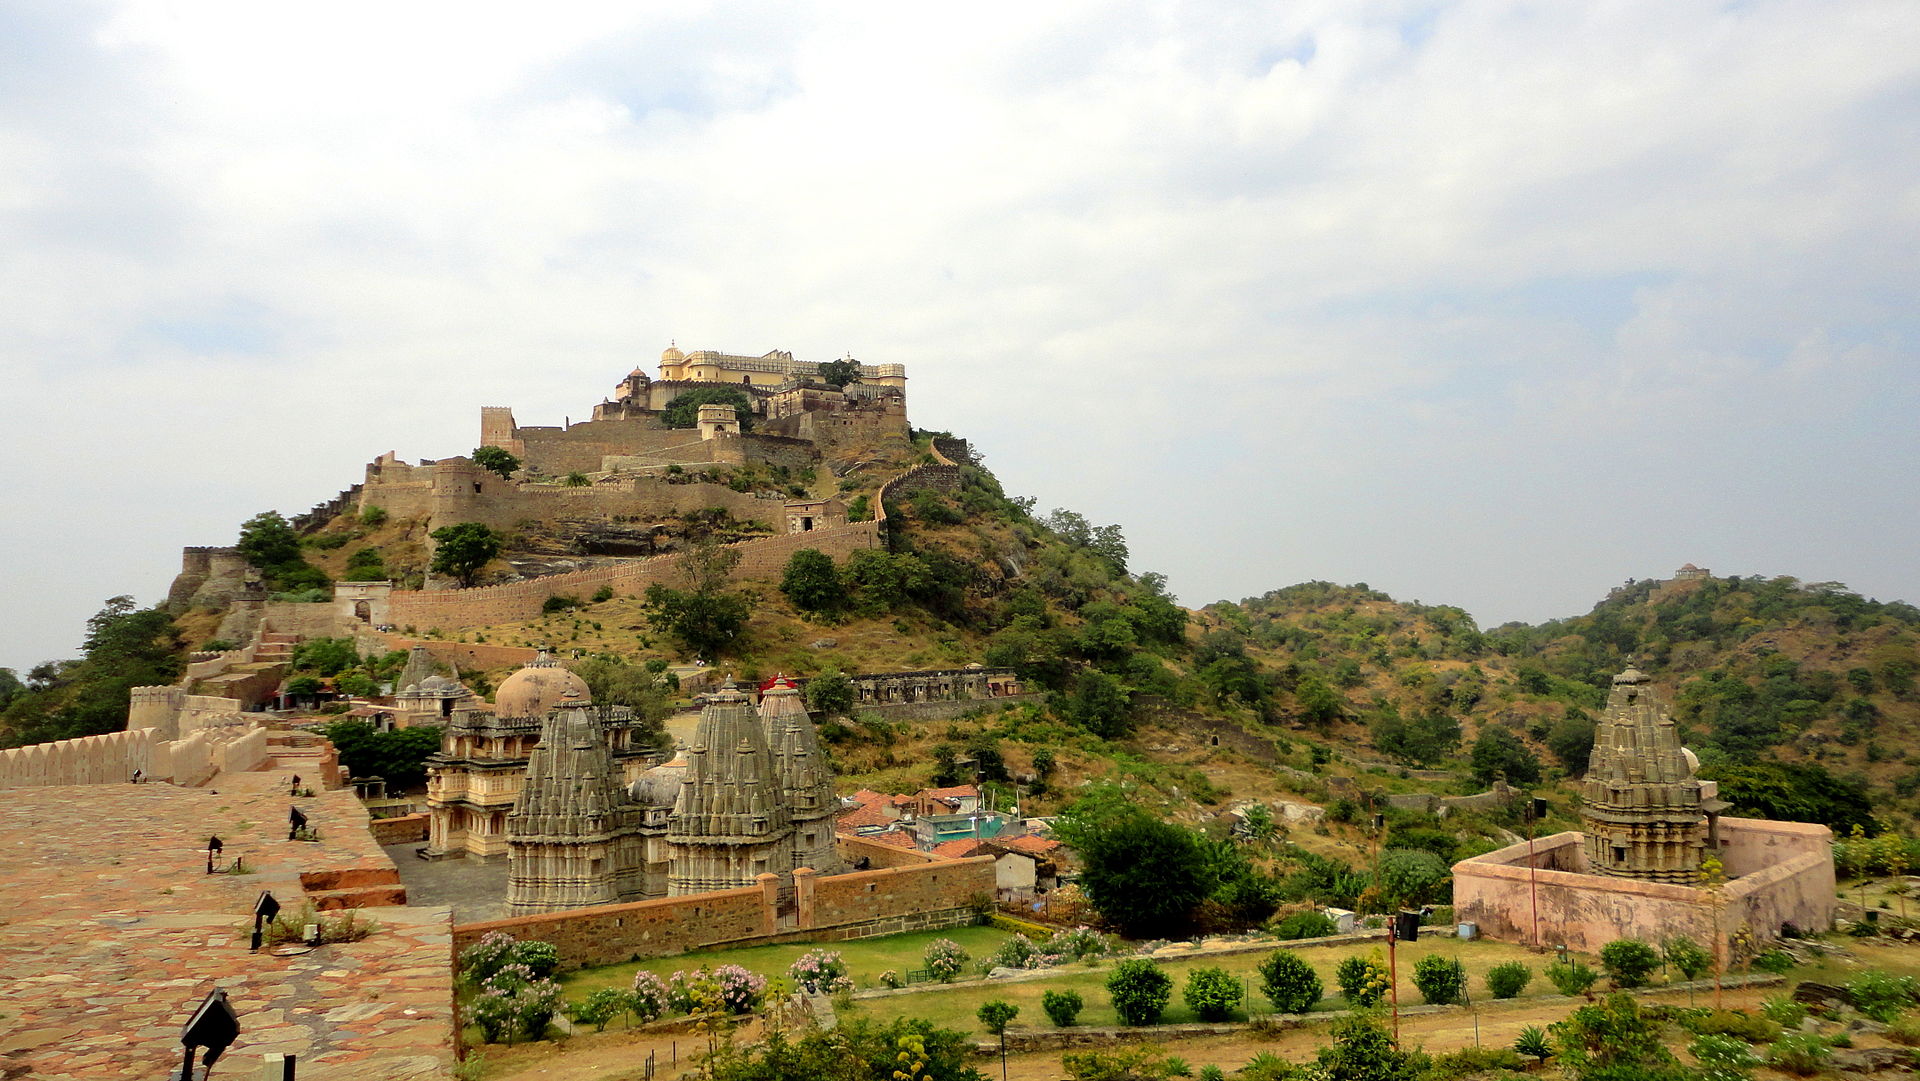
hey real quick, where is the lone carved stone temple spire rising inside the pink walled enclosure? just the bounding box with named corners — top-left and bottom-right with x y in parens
top-left (1580, 666), bottom-right (1711, 885)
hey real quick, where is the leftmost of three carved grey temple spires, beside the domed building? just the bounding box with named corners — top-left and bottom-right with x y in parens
top-left (507, 691), bottom-right (645, 916)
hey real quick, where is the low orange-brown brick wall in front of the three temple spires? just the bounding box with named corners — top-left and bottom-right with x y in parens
top-left (453, 856), bottom-right (993, 970)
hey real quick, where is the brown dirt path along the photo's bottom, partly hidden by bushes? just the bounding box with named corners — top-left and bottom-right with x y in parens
top-left (484, 987), bottom-right (1780, 1081)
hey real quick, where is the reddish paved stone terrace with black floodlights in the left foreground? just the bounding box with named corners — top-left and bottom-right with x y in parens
top-left (0, 770), bottom-right (453, 1081)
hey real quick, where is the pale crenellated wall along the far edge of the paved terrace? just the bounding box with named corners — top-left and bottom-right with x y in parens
top-left (0, 728), bottom-right (269, 789)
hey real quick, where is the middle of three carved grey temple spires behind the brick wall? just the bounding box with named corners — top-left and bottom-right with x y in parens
top-left (666, 680), bottom-right (793, 895)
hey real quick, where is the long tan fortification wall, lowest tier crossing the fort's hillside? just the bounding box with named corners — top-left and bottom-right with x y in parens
top-left (388, 522), bottom-right (879, 632)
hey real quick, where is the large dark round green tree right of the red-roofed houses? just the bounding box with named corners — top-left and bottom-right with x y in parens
top-left (1054, 787), bottom-right (1219, 939)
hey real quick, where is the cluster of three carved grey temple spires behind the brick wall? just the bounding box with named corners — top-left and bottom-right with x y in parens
top-left (507, 680), bottom-right (845, 916)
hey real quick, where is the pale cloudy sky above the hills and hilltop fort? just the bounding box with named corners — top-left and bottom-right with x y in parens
top-left (0, 0), bottom-right (1920, 668)
